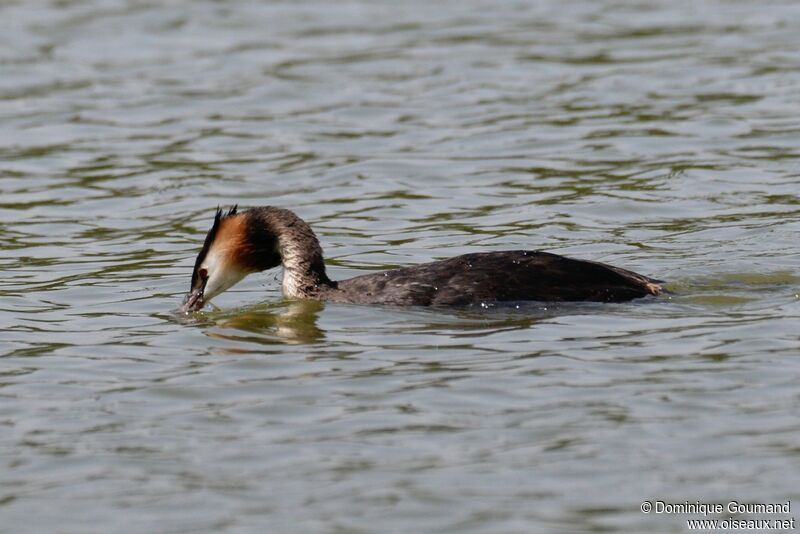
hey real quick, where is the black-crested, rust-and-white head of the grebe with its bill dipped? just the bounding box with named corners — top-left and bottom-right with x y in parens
top-left (180, 206), bottom-right (281, 312)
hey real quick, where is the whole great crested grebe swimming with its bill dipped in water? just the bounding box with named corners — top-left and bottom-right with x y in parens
top-left (180, 206), bottom-right (662, 312)
